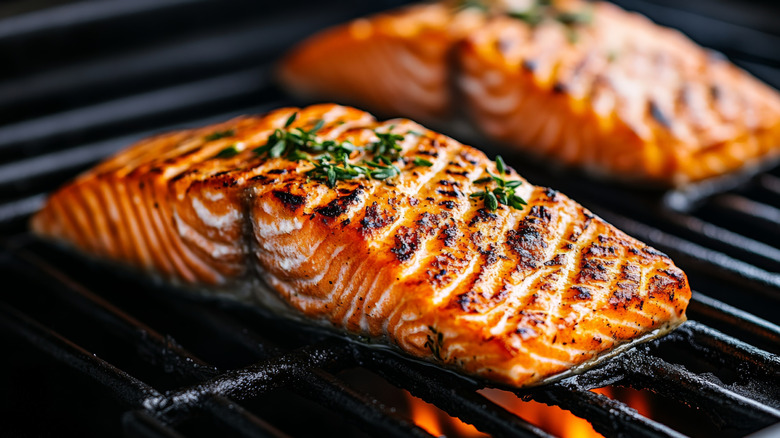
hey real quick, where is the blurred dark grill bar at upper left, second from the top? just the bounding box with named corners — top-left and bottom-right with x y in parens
top-left (0, 5), bottom-right (345, 120)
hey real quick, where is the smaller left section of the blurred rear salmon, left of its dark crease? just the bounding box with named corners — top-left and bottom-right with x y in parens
top-left (279, 3), bottom-right (486, 121)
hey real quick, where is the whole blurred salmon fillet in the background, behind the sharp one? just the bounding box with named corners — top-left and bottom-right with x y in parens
top-left (280, 0), bottom-right (780, 187)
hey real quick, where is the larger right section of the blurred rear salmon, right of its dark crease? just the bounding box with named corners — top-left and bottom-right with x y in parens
top-left (458, 1), bottom-right (780, 186)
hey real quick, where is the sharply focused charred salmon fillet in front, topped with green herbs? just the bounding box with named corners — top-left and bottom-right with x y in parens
top-left (32, 104), bottom-right (691, 386)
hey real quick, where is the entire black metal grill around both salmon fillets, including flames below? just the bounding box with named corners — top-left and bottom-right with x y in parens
top-left (0, 0), bottom-right (780, 437)
